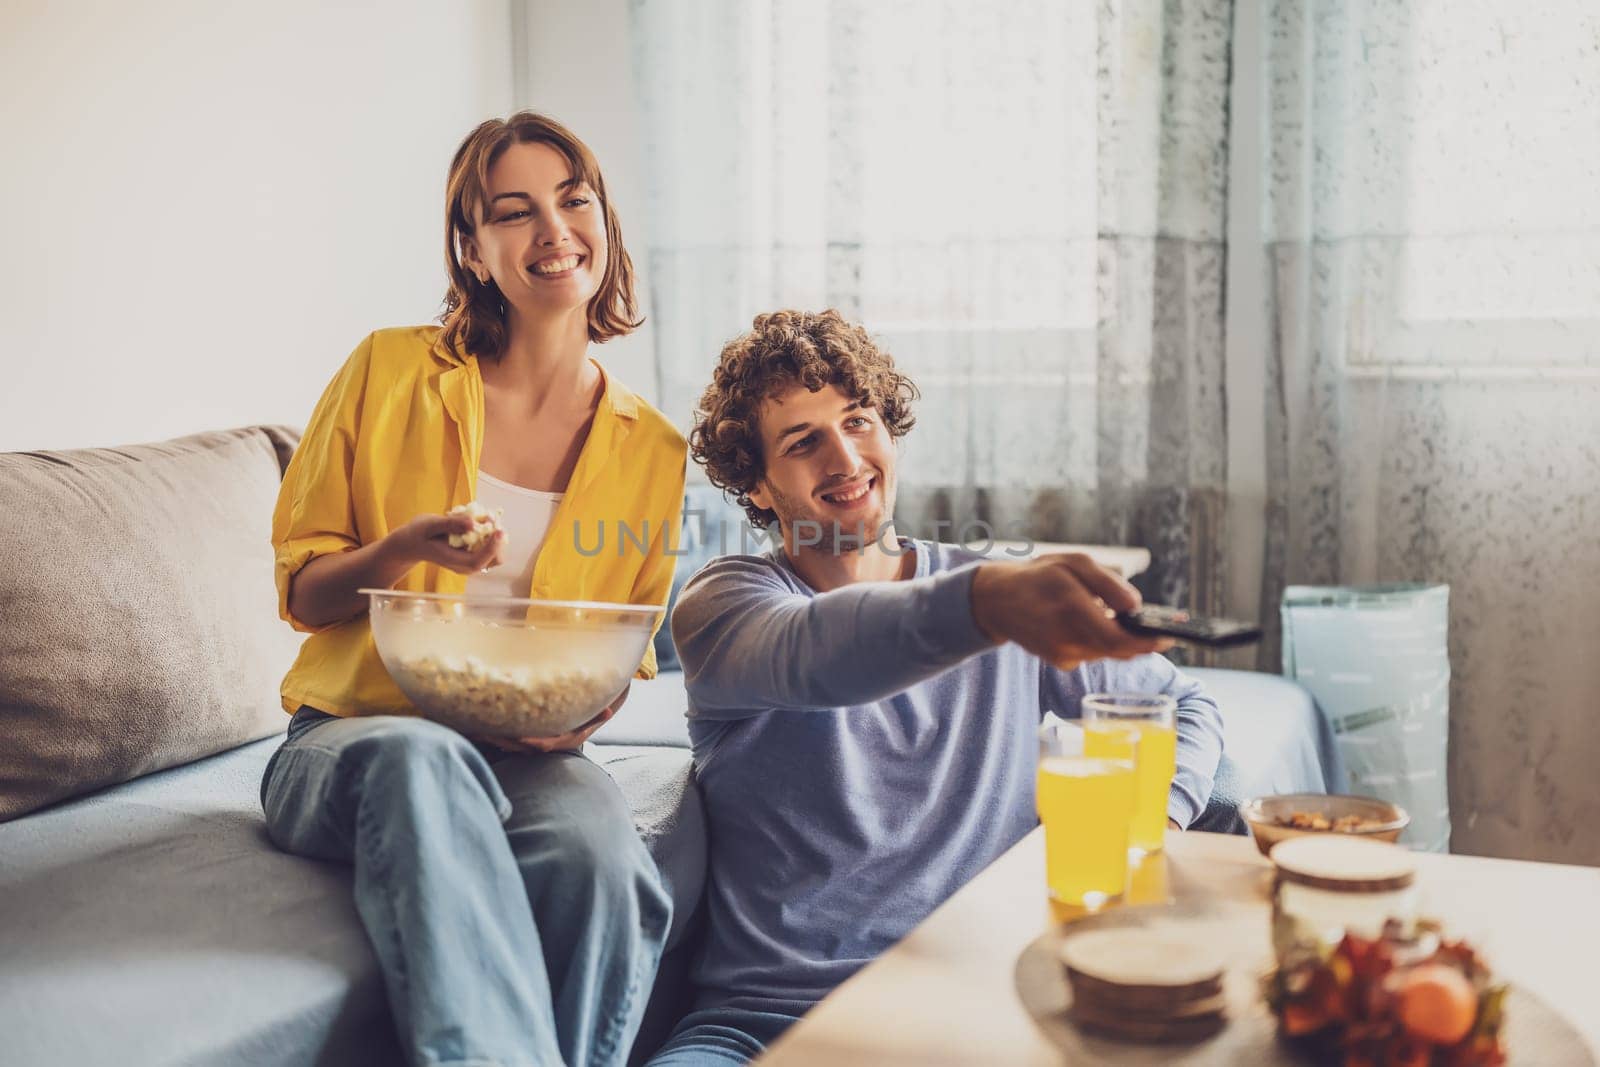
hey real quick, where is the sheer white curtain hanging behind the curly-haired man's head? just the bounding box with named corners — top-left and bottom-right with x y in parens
top-left (632, 0), bottom-right (1229, 627)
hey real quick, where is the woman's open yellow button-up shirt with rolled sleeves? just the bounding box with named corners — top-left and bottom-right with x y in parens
top-left (272, 326), bottom-right (686, 715)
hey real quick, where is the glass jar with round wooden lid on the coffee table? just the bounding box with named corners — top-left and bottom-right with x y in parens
top-left (1272, 833), bottom-right (1421, 963)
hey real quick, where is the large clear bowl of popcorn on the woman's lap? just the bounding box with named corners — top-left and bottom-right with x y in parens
top-left (362, 589), bottom-right (661, 737)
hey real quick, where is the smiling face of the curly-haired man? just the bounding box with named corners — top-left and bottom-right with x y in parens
top-left (750, 384), bottom-right (894, 552)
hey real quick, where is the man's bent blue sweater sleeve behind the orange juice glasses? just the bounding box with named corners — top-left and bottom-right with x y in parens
top-left (1042, 656), bottom-right (1222, 827)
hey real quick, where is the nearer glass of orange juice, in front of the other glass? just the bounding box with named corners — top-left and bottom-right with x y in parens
top-left (1037, 715), bottom-right (1141, 910)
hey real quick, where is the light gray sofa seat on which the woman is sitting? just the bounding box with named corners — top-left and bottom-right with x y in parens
top-left (0, 735), bottom-right (706, 1067)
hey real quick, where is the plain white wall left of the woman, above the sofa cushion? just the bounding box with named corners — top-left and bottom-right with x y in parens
top-left (0, 0), bottom-right (512, 450)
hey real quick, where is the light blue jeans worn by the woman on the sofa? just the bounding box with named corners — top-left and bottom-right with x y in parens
top-left (261, 707), bottom-right (672, 1067)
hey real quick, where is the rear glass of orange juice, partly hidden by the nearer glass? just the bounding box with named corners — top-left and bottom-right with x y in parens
top-left (1083, 693), bottom-right (1178, 853)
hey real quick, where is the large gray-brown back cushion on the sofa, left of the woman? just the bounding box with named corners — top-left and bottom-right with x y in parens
top-left (0, 429), bottom-right (299, 821)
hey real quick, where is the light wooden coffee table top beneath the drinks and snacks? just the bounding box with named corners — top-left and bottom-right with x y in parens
top-left (760, 830), bottom-right (1600, 1067)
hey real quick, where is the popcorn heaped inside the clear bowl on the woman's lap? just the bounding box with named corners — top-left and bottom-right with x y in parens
top-left (392, 656), bottom-right (629, 737)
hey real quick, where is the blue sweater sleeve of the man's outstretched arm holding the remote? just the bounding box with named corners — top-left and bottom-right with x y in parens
top-left (672, 555), bottom-right (994, 720)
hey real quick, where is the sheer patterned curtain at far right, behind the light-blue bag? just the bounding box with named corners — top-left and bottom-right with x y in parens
top-left (1262, 0), bottom-right (1600, 864)
